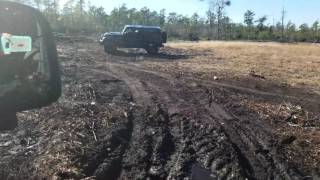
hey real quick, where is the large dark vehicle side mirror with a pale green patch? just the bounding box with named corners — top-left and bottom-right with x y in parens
top-left (0, 1), bottom-right (61, 130)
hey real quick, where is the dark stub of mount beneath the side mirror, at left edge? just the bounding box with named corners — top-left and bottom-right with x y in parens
top-left (0, 111), bottom-right (18, 131)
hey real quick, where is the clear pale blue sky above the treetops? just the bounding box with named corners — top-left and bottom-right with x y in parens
top-left (61, 0), bottom-right (320, 25)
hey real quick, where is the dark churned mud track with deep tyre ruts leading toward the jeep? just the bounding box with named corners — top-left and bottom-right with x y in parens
top-left (79, 48), bottom-right (303, 180)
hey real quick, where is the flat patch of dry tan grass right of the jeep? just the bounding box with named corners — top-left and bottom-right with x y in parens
top-left (162, 41), bottom-right (320, 93)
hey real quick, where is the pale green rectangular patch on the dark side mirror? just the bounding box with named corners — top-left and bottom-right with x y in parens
top-left (0, 34), bottom-right (32, 55)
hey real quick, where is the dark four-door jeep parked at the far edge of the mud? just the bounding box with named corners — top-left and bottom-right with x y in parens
top-left (100, 25), bottom-right (167, 54)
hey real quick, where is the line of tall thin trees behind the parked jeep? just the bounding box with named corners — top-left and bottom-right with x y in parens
top-left (4, 0), bottom-right (320, 42)
